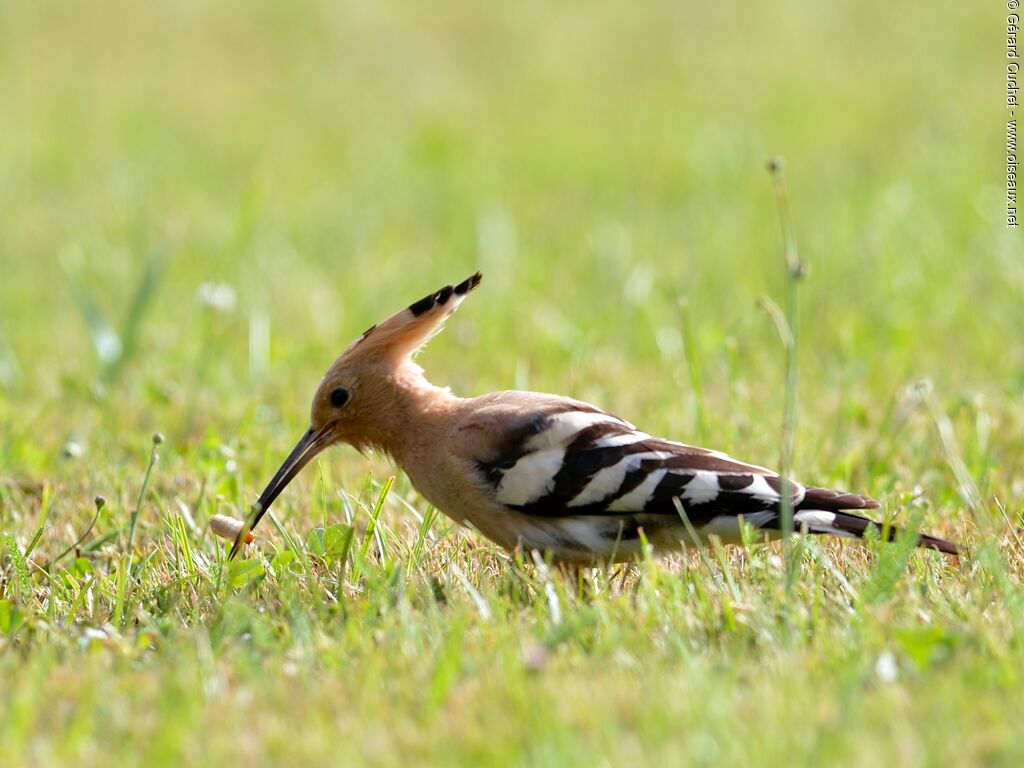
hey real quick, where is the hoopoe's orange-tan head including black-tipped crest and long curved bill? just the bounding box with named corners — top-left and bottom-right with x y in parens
top-left (231, 272), bottom-right (481, 556)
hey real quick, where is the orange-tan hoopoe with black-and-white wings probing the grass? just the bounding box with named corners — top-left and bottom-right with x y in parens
top-left (231, 272), bottom-right (958, 564)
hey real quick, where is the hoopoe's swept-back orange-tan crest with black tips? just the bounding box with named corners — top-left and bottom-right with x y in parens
top-left (335, 272), bottom-right (482, 365)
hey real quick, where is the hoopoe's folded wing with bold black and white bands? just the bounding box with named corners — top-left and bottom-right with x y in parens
top-left (456, 393), bottom-right (878, 525)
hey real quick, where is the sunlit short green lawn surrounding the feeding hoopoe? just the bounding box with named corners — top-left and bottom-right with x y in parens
top-left (0, 0), bottom-right (1024, 766)
